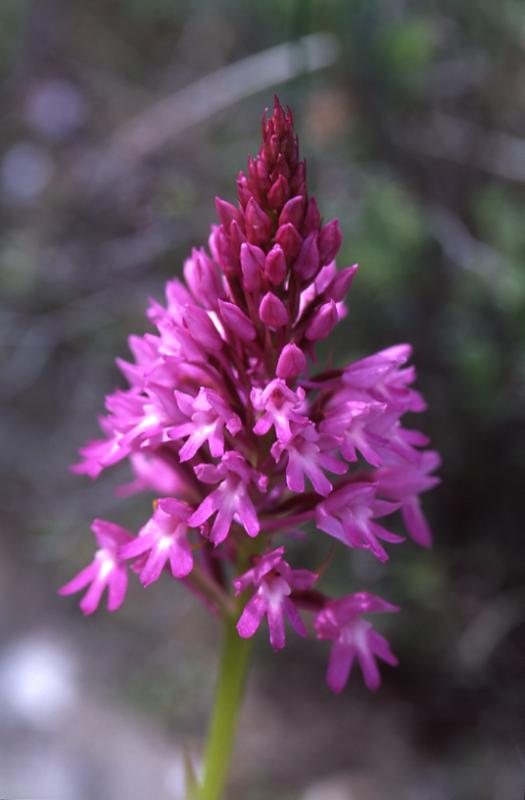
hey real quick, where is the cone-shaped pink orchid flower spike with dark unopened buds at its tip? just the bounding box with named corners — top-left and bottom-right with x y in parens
top-left (60, 100), bottom-right (439, 692)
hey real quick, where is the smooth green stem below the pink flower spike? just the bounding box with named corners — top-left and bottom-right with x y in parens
top-left (200, 617), bottom-right (252, 800)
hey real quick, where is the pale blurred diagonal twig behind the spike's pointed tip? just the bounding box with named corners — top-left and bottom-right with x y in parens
top-left (80, 33), bottom-right (339, 186)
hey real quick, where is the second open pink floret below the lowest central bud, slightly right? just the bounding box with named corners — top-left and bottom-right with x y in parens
top-left (271, 422), bottom-right (348, 496)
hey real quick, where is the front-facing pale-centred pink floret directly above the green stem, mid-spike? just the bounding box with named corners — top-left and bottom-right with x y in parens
top-left (188, 450), bottom-right (267, 545)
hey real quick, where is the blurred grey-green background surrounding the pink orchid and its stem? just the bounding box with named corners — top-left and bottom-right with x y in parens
top-left (0, 0), bottom-right (525, 800)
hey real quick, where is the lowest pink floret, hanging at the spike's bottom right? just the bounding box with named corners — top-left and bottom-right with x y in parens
top-left (314, 592), bottom-right (399, 694)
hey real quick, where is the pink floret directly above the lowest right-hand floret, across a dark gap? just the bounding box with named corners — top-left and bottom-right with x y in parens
top-left (316, 482), bottom-right (403, 561)
